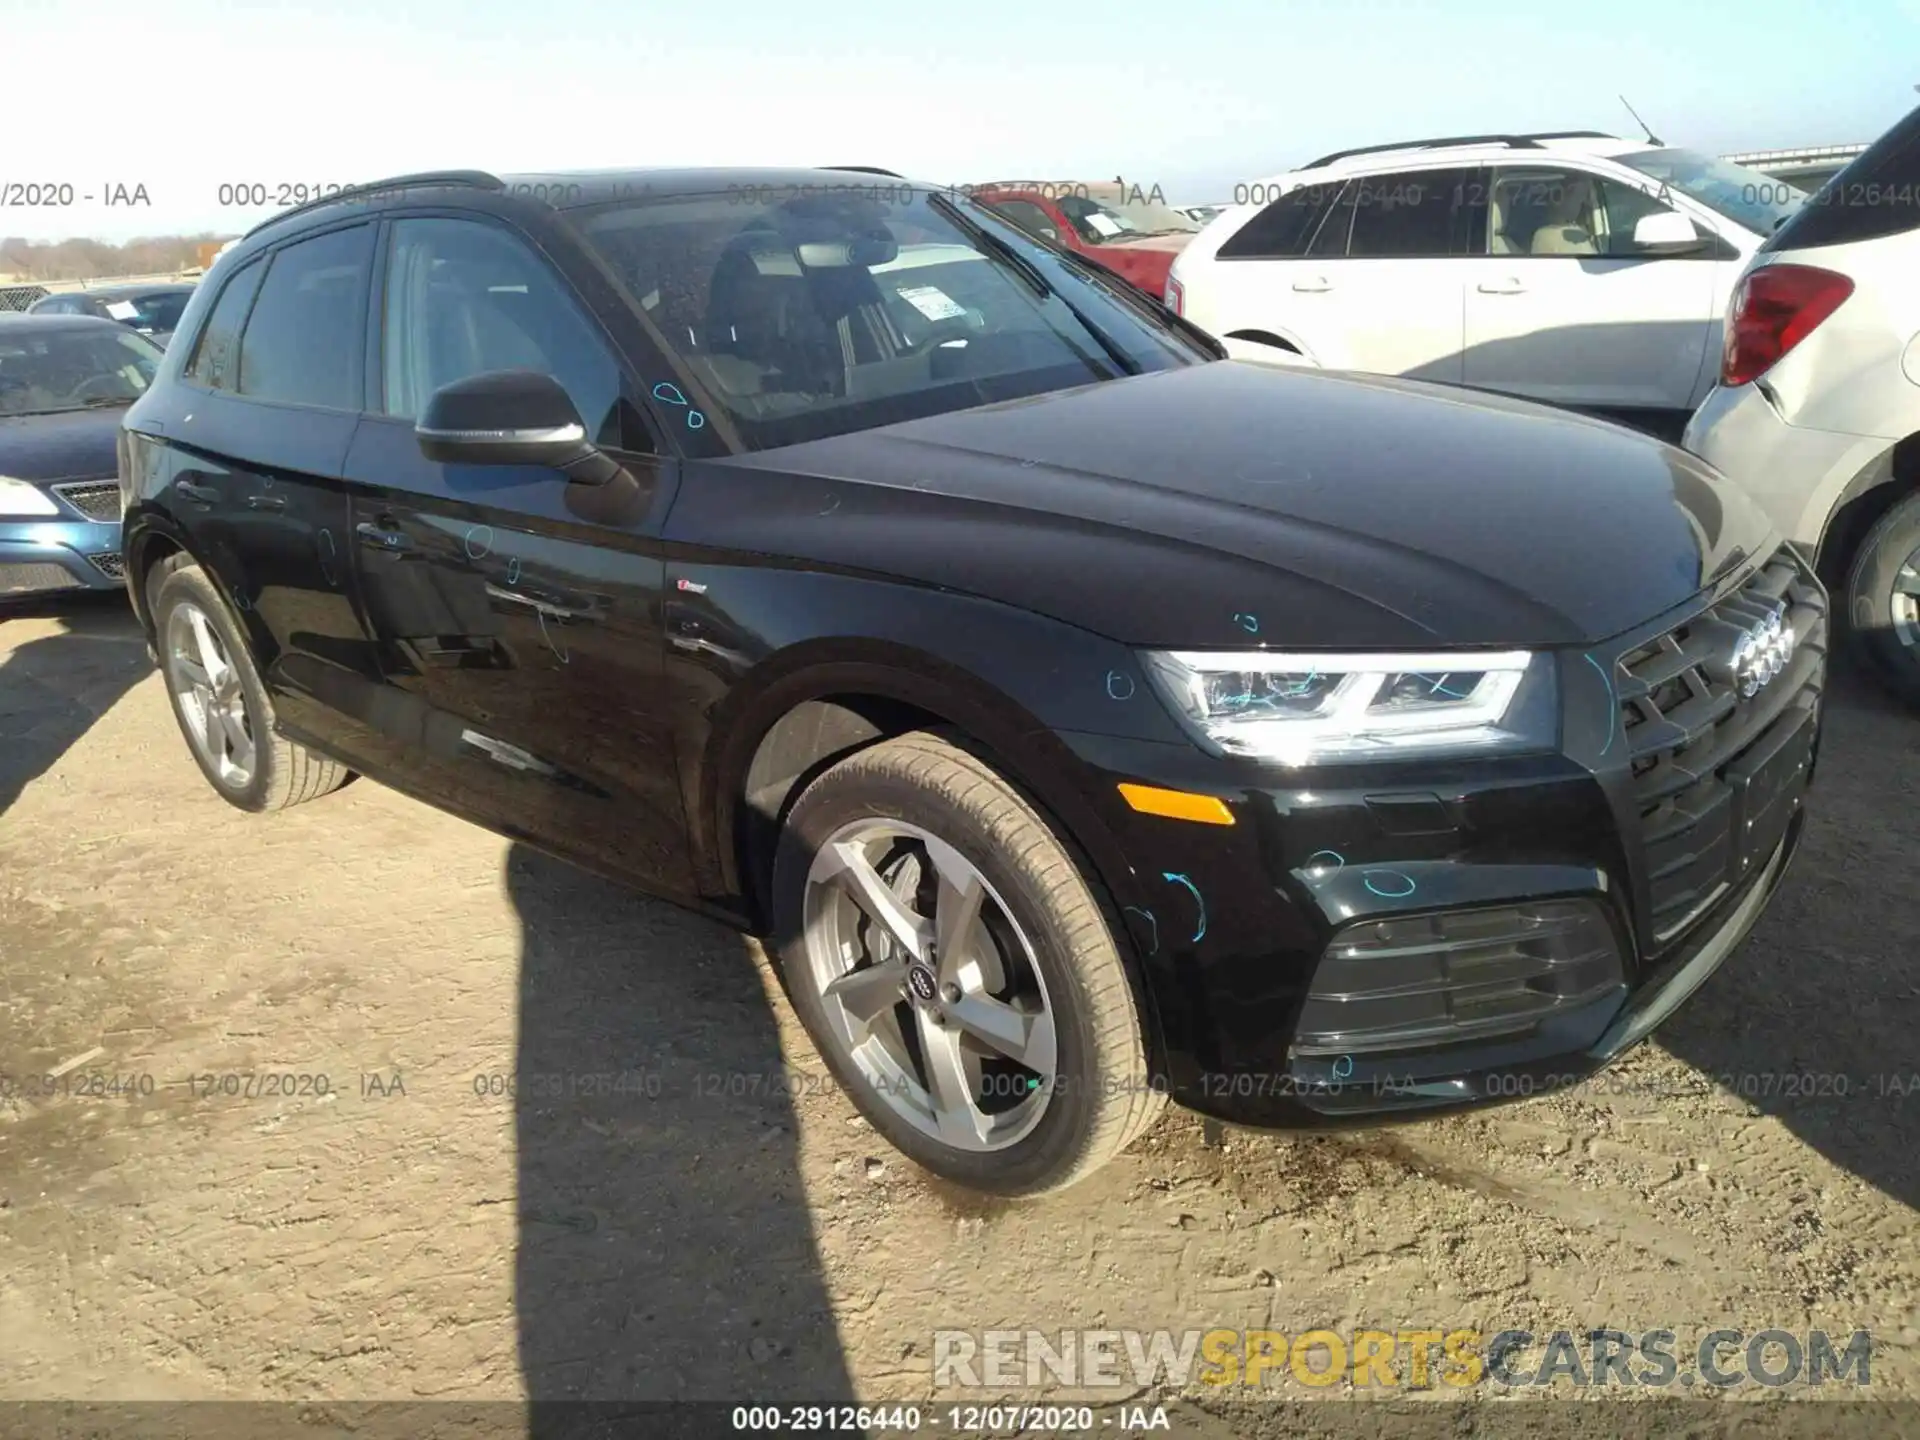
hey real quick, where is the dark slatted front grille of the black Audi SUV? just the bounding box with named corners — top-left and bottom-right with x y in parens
top-left (1617, 549), bottom-right (1828, 948)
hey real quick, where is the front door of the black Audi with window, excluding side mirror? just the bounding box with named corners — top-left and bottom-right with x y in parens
top-left (348, 213), bottom-right (693, 895)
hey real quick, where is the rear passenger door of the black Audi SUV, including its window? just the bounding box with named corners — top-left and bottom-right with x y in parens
top-left (154, 223), bottom-right (389, 764)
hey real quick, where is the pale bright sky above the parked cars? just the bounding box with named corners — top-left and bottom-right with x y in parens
top-left (0, 0), bottom-right (1920, 240)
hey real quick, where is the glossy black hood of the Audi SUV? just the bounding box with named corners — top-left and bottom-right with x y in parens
top-left (721, 361), bottom-right (1772, 649)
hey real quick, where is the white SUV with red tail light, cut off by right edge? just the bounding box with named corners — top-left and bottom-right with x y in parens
top-left (1682, 109), bottom-right (1920, 705)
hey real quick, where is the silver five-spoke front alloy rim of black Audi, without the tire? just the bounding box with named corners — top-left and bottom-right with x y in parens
top-left (804, 820), bottom-right (1058, 1152)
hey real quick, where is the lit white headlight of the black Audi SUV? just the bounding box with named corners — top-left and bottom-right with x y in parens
top-left (1144, 651), bottom-right (1559, 764)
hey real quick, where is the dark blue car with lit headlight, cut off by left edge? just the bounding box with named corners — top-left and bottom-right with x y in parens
top-left (0, 315), bottom-right (161, 599)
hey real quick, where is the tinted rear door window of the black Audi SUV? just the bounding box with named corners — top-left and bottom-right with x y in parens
top-left (240, 225), bottom-right (372, 411)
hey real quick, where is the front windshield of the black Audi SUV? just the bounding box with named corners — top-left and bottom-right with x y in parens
top-left (564, 184), bottom-right (1212, 453)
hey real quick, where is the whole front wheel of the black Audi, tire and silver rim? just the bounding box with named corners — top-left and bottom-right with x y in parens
top-left (774, 733), bottom-right (1165, 1196)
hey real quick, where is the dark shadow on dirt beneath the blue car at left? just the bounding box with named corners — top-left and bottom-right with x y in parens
top-left (0, 595), bottom-right (154, 816)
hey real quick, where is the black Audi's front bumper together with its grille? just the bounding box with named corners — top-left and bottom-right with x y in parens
top-left (1071, 551), bottom-right (1828, 1129)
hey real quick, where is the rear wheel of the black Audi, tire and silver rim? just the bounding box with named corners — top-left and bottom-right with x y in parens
top-left (148, 555), bottom-right (355, 814)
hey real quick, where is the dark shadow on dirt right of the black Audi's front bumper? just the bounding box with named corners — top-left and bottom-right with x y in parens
top-left (1655, 659), bottom-right (1920, 1208)
